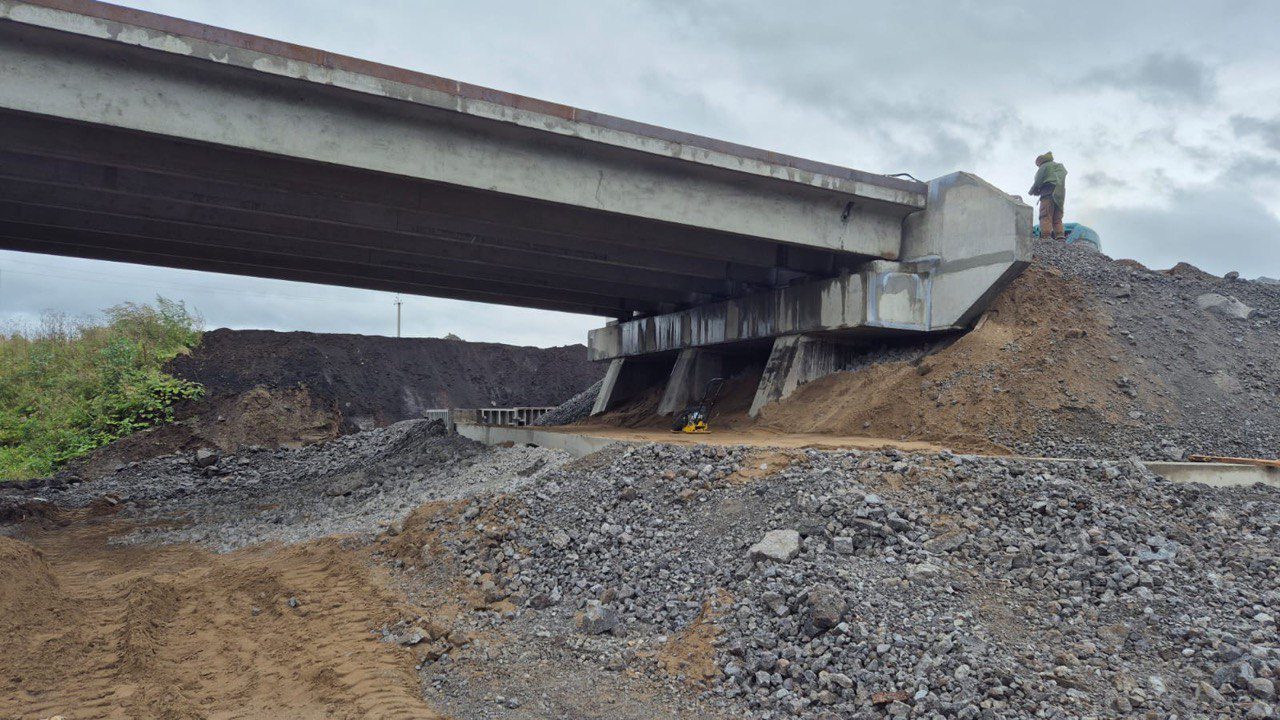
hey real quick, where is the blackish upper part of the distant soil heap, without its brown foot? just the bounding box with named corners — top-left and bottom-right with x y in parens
top-left (169, 329), bottom-right (604, 432)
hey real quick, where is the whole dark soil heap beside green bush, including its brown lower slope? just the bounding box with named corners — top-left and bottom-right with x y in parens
top-left (65, 328), bottom-right (604, 478)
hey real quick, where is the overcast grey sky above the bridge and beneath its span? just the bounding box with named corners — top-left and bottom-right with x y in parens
top-left (0, 0), bottom-right (1280, 345)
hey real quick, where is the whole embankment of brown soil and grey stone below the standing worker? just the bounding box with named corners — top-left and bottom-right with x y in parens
top-left (756, 241), bottom-right (1280, 459)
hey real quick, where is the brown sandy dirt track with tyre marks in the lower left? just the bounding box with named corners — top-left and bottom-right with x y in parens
top-left (0, 523), bottom-right (439, 720)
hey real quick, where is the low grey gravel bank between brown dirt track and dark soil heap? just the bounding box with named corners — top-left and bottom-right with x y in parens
top-left (0, 420), bottom-right (568, 551)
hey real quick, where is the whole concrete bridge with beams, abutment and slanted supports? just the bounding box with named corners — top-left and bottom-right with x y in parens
top-left (0, 0), bottom-right (1032, 411)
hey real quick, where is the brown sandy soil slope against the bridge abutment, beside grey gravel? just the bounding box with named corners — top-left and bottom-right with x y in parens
top-left (759, 266), bottom-right (1167, 452)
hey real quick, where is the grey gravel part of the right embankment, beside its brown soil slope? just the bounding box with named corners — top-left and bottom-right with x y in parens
top-left (1009, 241), bottom-right (1280, 459)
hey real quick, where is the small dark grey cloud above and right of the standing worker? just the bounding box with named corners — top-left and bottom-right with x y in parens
top-left (1079, 53), bottom-right (1217, 104)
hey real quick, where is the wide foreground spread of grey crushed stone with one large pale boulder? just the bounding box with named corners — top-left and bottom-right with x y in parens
top-left (428, 446), bottom-right (1280, 719)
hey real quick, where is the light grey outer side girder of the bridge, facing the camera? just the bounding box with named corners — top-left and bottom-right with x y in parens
top-left (0, 13), bottom-right (923, 259)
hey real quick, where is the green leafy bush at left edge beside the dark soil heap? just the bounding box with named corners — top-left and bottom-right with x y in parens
top-left (0, 297), bottom-right (204, 480)
